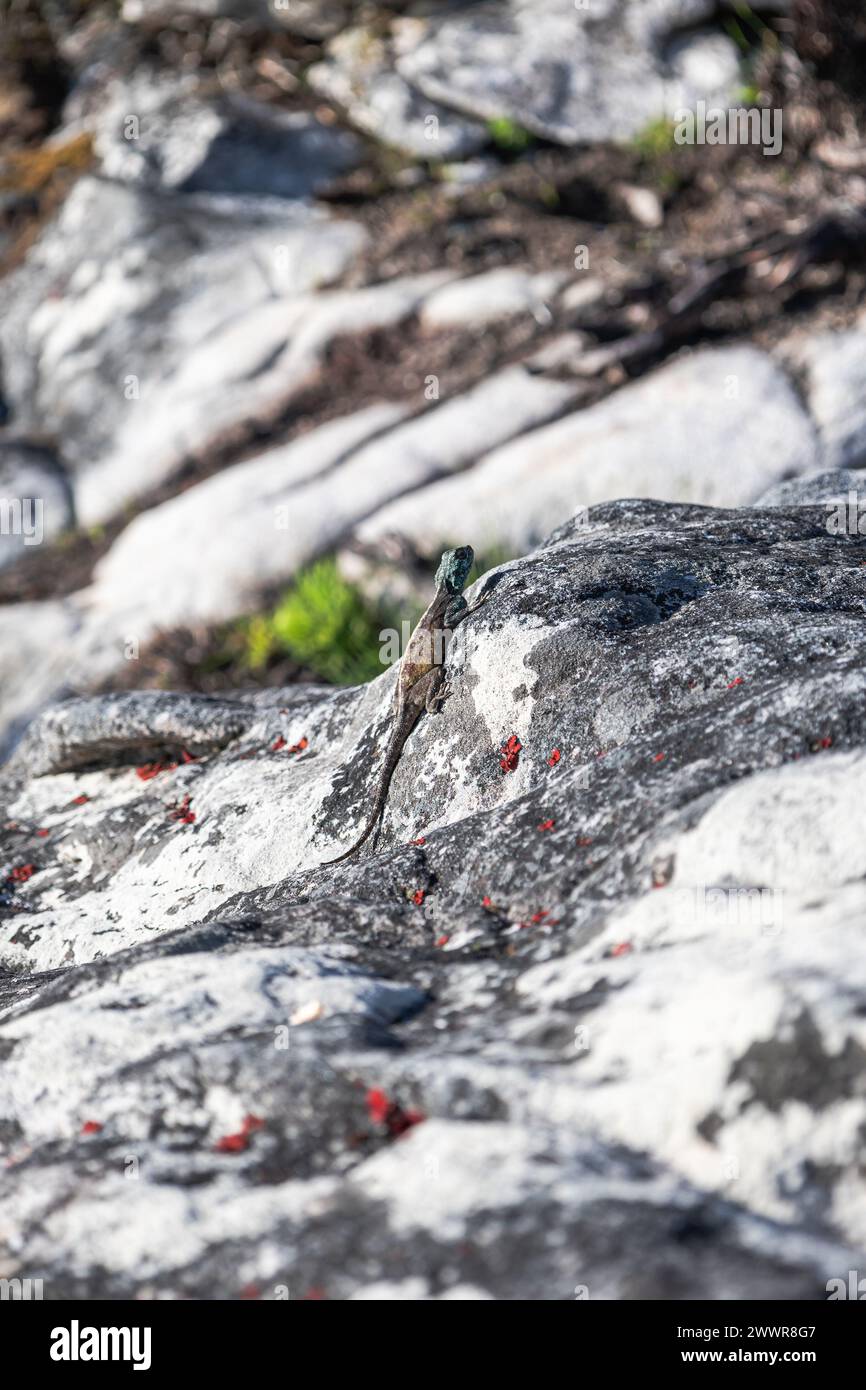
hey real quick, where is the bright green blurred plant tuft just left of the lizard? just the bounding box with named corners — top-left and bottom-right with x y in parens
top-left (243, 559), bottom-right (397, 685)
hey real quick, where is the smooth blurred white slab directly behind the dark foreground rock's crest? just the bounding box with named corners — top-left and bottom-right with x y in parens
top-left (360, 346), bottom-right (817, 553)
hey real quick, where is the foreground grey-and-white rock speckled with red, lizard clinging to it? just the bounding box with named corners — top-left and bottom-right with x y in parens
top-left (0, 497), bottom-right (866, 1301)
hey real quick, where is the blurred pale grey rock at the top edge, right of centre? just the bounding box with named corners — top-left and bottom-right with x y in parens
top-left (398, 0), bottom-right (738, 145)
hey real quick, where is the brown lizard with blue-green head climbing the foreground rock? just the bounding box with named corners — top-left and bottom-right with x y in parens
top-left (324, 545), bottom-right (478, 865)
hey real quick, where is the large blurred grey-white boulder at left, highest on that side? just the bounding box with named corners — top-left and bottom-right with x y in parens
top-left (0, 178), bottom-right (364, 524)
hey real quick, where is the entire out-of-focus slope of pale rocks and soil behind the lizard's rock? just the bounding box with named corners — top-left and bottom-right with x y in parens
top-left (0, 0), bottom-right (866, 746)
